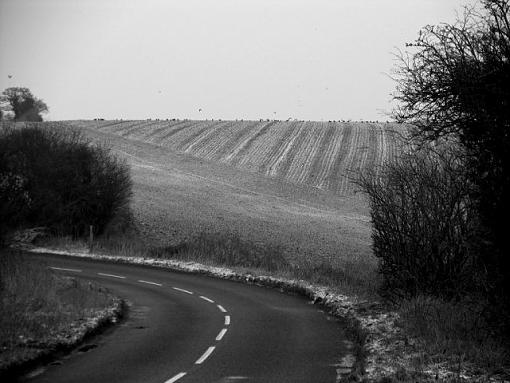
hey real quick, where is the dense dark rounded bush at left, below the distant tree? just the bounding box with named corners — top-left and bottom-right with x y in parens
top-left (0, 124), bottom-right (131, 240)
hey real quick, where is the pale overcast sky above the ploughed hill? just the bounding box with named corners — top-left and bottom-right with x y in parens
top-left (0, 0), bottom-right (469, 120)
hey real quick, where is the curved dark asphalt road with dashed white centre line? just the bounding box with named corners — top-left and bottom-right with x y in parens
top-left (22, 255), bottom-right (346, 383)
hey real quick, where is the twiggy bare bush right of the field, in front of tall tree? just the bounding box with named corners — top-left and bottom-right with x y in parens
top-left (360, 145), bottom-right (475, 299)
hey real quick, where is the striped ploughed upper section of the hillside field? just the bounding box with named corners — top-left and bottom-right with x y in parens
top-left (68, 120), bottom-right (402, 196)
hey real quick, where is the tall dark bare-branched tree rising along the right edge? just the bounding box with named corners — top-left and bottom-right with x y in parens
top-left (395, 0), bottom-right (510, 333)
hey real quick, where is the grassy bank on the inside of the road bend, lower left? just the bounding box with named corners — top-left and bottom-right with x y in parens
top-left (0, 249), bottom-right (118, 376)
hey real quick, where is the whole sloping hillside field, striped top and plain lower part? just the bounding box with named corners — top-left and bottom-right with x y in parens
top-left (65, 120), bottom-right (402, 296)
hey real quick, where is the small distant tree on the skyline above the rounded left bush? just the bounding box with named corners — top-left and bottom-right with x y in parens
top-left (0, 87), bottom-right (48, 121)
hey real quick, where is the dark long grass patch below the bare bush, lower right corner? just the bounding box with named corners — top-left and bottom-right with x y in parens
top-left (399, 296), bottom-right (510, 374)
